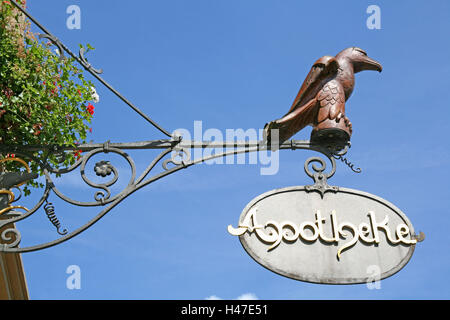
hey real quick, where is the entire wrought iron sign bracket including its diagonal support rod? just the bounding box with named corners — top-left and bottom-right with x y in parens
top-left (0, 0), bottom-right (360, 253)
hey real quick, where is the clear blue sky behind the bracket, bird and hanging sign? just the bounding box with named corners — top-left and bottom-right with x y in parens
top-left (11, 0), bottom-right (450, 299)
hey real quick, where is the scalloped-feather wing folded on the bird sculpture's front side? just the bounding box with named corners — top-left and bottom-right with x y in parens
top-left (317, 80), bottom-right (345, 123)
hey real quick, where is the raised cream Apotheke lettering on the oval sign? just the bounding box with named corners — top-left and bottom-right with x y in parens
top-left (228, 207), bottom-right (417, 260)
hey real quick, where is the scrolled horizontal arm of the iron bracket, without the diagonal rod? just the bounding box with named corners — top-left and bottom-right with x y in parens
top-left (0, 135), bottom-right (358, 252)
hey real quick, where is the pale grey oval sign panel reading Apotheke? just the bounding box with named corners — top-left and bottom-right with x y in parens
top-left (228, 186), bottom-right (417, 284)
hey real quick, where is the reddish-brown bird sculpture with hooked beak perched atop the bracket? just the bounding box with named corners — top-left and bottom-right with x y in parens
top-left (264, 47), bottom-right (382, 150)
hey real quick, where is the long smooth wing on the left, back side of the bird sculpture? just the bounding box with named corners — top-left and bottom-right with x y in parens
top-left (286, 56), bottom-right (339, 115)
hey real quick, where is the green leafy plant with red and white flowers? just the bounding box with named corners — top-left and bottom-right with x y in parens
top-left (0, 1), bottom-right (94, 194)
